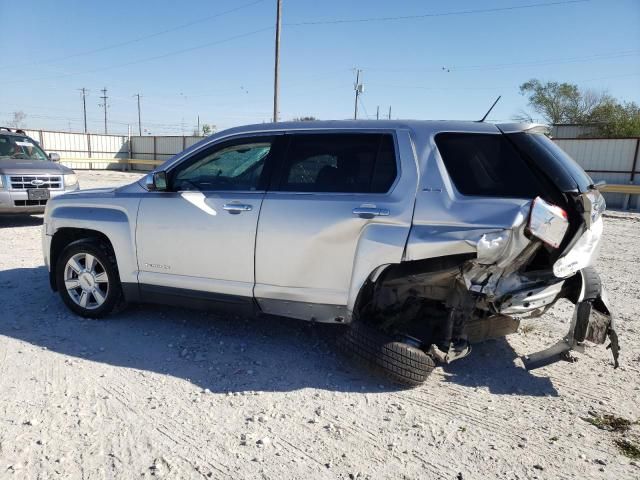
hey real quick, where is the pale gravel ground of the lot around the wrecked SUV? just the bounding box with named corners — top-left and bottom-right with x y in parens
top-left (0, 172), bottom-right (640, 479)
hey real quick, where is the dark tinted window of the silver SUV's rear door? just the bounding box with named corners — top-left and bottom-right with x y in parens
top-left (278, 133), bottom-right (397, 193)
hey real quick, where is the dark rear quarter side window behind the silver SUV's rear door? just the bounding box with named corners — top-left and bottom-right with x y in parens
top-left (435, 133), bottom-right (543, 198)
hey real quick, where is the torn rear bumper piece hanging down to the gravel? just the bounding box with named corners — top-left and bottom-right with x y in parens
top-left (522, 267), bottom-right (620, 370)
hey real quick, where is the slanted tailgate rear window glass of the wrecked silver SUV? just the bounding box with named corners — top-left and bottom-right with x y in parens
top-left (507, 132), bottom-right (593, 193)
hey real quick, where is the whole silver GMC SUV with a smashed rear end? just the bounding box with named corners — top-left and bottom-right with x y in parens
top-left (43, 121), bottom-right (617, 384)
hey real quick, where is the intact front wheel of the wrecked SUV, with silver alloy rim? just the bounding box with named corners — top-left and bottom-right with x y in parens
top-left (56, 239), bottom-right (122, 318)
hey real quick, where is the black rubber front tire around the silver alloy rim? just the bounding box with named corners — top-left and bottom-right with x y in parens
top-left (56, 239), bottom-right (122, 318)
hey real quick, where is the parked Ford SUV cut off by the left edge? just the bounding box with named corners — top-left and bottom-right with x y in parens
top-left (0, 127), bottom-right (79, 214)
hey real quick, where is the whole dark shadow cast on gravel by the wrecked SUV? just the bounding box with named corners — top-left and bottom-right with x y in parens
top-left (0, 267), bottom-right (555, 395)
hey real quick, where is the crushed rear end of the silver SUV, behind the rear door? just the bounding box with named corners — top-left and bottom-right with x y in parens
top-left (342, 124), bottom-right (619, 385)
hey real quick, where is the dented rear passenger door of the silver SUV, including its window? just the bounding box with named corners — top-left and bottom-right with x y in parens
top-left (254, 131), bottom-right (416, 321)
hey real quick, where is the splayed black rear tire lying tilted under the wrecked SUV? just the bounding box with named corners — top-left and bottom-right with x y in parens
top-left (338, 322), bottom-right (436, 386)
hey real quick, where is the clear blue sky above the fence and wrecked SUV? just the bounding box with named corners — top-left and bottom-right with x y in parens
top-left (0, 0), bottom-right (640, 134)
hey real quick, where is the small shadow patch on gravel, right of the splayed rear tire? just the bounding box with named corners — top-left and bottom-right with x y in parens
top-left (444, 337), bottom-right (558, 397)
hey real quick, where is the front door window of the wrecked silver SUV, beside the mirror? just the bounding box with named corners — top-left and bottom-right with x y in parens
top-left (172, 138), bottom-right (272, 191)
